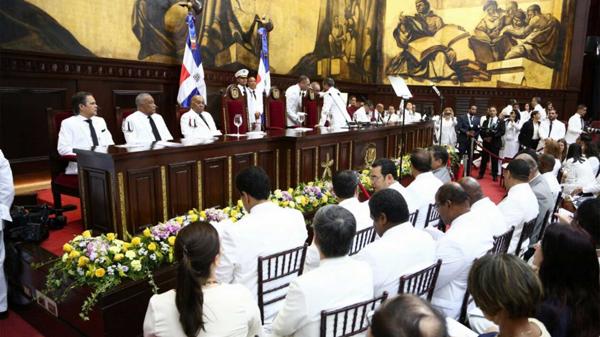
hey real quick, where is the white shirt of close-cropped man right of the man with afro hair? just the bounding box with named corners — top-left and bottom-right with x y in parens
top-left (431, 210), bottom-right (492, 319)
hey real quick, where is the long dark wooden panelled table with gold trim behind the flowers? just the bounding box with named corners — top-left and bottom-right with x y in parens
top-left (75, 122), bottom-right (433, 237)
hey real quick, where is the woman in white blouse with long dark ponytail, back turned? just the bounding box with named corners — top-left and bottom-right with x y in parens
top-left (144, 222), bottom-right (263, 337)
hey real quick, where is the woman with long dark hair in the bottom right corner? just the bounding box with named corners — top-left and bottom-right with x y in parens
top-left (533, 223), bottom-right (600, 337)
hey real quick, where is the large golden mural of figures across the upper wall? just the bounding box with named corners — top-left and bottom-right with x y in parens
top-left (0, 0), bottom-right (573, 88)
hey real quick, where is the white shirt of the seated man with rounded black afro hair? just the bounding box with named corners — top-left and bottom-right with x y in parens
top-left (354, 222), bottom-right (435, 297)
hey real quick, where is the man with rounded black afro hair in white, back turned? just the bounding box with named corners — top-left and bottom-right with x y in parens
top-left (354, 188), bottom-right (435, 297)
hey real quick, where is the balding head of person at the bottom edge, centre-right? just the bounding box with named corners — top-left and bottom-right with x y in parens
top-left (368, 294), bottom-right (448, 337)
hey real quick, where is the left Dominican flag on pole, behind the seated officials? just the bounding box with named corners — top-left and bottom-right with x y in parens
top-left (177, 13), bottom-right (207, 108)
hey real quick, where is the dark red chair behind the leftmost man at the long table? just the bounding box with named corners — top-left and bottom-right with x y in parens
top-left (46, 108), bottom-right (79, 208)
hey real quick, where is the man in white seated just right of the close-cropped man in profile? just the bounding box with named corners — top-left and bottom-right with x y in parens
top-left (458, 177), bottom-right (509, 236)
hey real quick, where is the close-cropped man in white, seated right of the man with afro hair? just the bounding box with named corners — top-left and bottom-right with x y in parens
top-left (431, 182), bottom-right (493, 319)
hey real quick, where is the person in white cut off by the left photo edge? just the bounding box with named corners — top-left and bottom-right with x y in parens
top-left (0, 150), bottom-right (15, 320)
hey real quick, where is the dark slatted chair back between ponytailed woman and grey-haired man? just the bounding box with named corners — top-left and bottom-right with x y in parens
top-left (257, 244), bottom-right (308, 324)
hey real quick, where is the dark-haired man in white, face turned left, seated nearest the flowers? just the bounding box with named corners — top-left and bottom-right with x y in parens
top-left (371, 158), bottom-right (420, 213)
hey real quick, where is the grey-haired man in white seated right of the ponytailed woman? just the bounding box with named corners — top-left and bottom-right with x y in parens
top-left (272, 205), bottom-right (373, 337)
